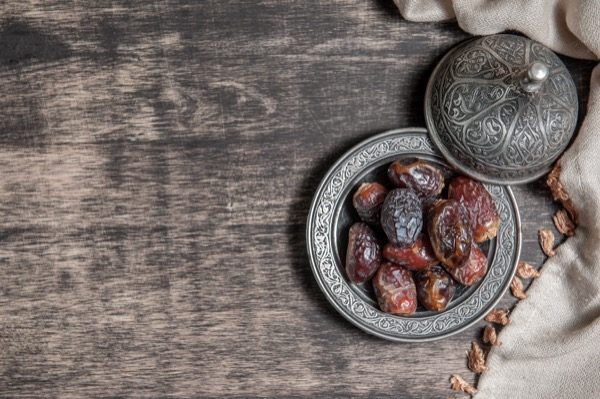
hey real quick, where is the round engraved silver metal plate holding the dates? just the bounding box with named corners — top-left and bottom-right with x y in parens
top-left (306, 128), bottom-right (521, 341)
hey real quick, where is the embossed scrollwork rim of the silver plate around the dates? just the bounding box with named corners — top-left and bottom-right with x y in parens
top-left (307, 132), bottom-right (520, 341)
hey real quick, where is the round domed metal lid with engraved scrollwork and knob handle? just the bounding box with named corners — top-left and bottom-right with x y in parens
top-left (425, 34), bottom-right (578, 184)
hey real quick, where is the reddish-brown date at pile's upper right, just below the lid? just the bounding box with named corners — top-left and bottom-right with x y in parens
top-left (448, 176), bottom-right (500, 242)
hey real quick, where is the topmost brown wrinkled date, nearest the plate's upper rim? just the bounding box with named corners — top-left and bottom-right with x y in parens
top-left (388, 160), bottom-right (444, 201)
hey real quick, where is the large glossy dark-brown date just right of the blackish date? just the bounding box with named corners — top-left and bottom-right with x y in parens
top-left (428, 200), bottom-right (473, 269)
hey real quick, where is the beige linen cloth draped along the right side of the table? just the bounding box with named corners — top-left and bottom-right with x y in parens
top-left (395, 0), bottom-right (600, 399)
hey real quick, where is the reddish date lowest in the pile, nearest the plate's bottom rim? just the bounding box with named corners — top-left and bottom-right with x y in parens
top-left (373, 262), bottom-right (417, 315)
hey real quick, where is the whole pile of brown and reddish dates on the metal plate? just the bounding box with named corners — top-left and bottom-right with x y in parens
top-left (346, 159), bottom-right (500, 315)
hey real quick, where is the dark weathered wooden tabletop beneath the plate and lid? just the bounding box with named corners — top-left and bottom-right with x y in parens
top-left (0, 0), bottom-right (592, 398)
